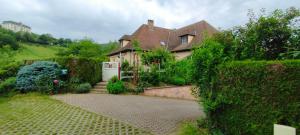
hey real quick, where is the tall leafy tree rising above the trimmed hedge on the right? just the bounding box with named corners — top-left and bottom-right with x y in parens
top-left (234, 8), bottom-right (300, 60)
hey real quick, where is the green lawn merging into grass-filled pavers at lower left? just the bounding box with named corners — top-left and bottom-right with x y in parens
top-left (0, 93), bottom-right (148, 135)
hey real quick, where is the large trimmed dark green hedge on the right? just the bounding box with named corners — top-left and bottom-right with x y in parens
top-left (211, 60), bottom-right (300, 135)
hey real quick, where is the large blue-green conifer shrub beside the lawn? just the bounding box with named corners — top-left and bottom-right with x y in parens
top-left (16, 61), bottom-right (60, 93)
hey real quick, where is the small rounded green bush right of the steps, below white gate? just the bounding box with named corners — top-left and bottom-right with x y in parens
top-left (106, 77), bottom-right (126, 94)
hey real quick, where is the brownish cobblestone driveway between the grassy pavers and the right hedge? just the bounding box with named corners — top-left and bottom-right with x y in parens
top-left (53, 94), bottom-right (204, 135)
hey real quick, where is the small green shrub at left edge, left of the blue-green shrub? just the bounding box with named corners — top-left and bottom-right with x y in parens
top-left (0, 77), bottom-right (16, 95)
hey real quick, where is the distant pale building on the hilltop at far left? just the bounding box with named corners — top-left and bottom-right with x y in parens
top-left (1, 21), bottom-right (31, 32)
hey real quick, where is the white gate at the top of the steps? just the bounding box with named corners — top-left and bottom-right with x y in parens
top-left (102, 62), bottom-right (119, 81)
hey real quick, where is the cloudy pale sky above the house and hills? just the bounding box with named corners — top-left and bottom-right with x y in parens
top-left (0, 0), bottom-right (300, 43)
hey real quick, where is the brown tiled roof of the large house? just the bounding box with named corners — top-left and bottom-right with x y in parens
top-left (109, 21), bottom-right (218, 55)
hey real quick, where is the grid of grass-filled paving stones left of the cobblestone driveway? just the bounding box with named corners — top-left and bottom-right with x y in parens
top-left (0, 95), bottom-right (150, 135)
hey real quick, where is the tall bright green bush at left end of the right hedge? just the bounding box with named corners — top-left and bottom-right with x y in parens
top-left (192, 39), bottom-right (231, 94)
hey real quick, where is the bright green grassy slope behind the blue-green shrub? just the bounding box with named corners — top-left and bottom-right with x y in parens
top-left (14, 43), bottom-right (64, 61)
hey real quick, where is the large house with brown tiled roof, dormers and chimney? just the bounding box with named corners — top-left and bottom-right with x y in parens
top-left (108, 20), bottom-right (218, 64)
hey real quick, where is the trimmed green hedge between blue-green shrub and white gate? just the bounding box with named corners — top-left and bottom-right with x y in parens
top-left (25, 57), bottom-right (102, 85)
